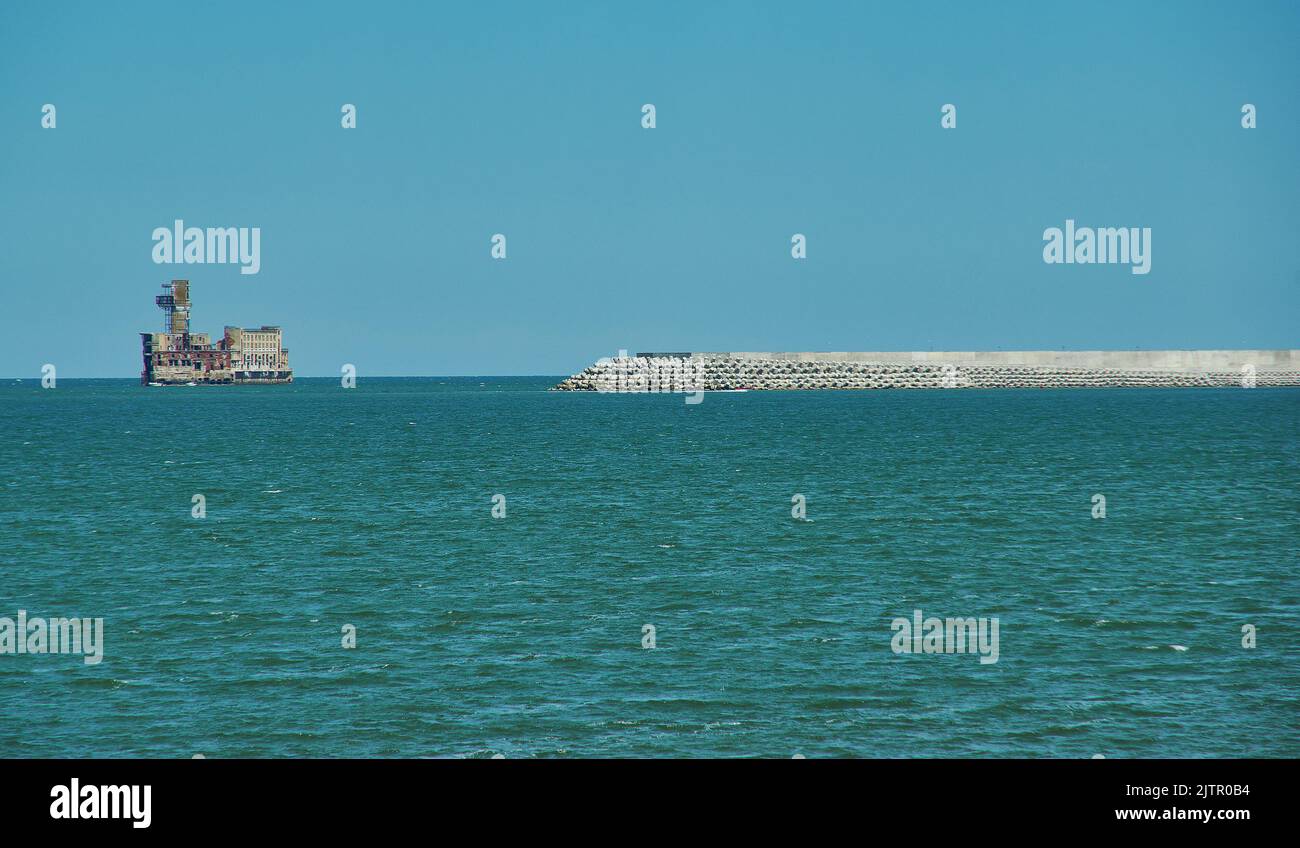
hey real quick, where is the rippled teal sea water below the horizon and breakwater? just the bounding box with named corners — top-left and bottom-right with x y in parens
top-left (0, 377), bottom-right (1300, 758)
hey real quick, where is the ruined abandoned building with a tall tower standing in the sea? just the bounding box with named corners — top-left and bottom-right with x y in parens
top-left (140, 280), bottom-right (294, 385)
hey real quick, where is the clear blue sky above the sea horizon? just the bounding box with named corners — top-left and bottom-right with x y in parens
top-left (0, 0), bottom-right (1300, 378)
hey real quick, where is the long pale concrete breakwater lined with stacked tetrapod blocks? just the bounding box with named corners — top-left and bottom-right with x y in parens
top-left (555, 350), bottom-right (1300, 391)
